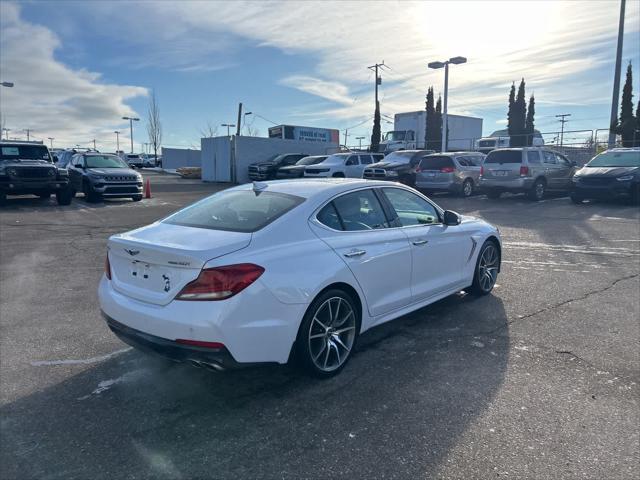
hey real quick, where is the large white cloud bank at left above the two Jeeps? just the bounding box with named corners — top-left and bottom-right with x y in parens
top-left (0, 2), bottom-right (147, 149)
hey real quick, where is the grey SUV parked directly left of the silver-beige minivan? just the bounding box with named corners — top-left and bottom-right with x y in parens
top-left (415, 152), bottom-right (484, 197)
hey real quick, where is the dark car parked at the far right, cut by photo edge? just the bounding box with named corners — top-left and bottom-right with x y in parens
top-left (571, 148), bottom-right (640, 204)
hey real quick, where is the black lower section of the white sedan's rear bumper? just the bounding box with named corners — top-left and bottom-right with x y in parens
top-left (102, 312), bottom-right (244, 370)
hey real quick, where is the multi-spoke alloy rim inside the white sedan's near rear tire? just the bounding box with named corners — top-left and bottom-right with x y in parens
top-left (307, 297), bottom-right (356, 372)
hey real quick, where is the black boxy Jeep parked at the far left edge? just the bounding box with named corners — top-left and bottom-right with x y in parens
top-left (0, 141), bottom-right (72, 205)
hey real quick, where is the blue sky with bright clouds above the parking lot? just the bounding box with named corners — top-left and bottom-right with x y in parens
top-left (0, 0), bottom-right (640, 150)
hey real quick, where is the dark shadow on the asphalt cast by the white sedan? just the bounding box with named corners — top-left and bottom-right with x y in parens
top-left (0, 294), bottom-right (509, 479)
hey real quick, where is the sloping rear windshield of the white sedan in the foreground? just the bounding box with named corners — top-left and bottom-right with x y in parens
top-left (164, 190), bottom-right (304, 233)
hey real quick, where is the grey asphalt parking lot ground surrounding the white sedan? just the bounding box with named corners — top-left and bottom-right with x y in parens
top-left (0, 174), bottom-right (640, 479)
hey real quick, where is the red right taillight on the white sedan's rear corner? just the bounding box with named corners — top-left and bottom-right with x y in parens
top-left (176, 263), bottom-right (264, 300)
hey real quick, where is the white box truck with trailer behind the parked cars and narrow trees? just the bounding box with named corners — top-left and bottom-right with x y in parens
top-left (380, 110), bottom-right (482, 153)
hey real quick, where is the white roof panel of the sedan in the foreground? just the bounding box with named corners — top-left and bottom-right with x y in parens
top-left (230, 178), bottom-right (393, 199)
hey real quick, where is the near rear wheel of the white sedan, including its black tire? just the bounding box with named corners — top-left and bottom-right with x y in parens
top-left (295, 289), bottom-right (360, 378)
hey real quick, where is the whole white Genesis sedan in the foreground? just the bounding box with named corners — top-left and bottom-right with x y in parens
top-left (99, 179), bottom-right (501, 377)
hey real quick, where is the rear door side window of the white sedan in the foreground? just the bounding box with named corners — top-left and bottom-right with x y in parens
top-left (333, 189), bottom-right (389, 232)
